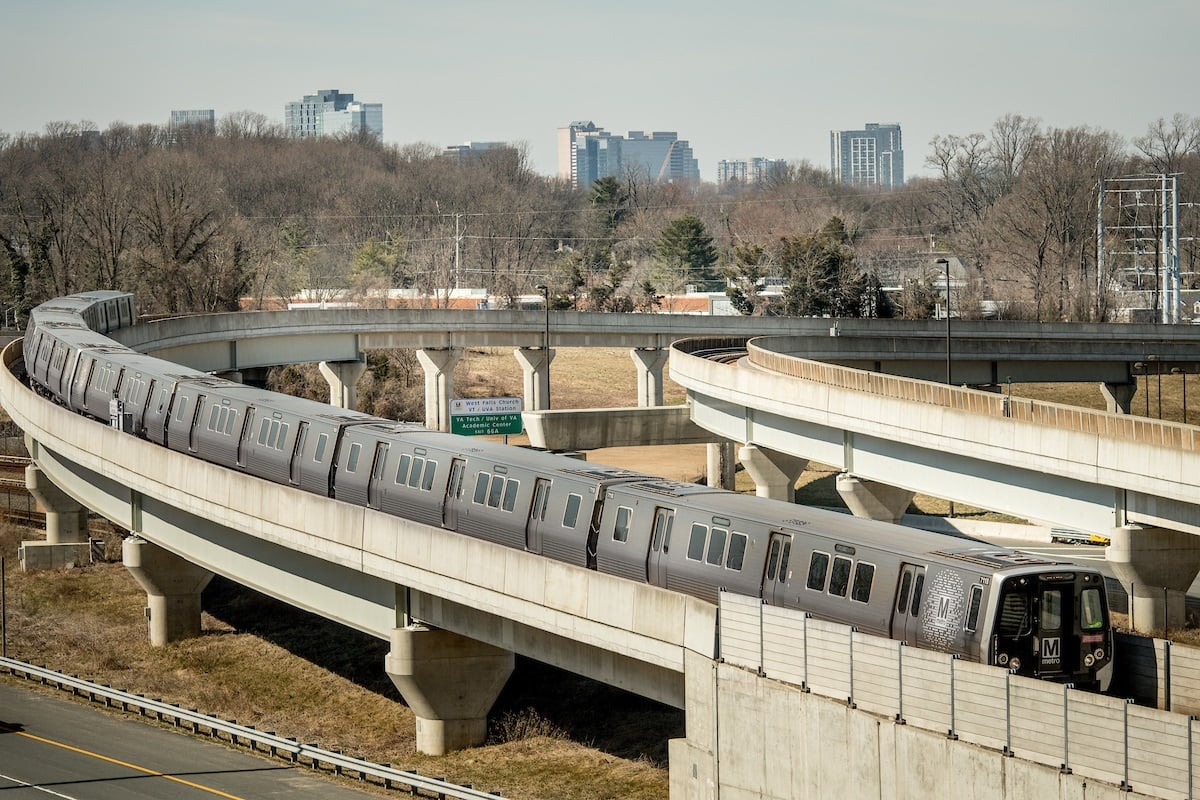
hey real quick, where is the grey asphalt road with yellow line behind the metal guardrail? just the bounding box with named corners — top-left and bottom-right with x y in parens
top-left (0, 682), bottom-right (374, 800)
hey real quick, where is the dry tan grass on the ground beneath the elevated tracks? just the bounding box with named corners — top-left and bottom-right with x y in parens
top-left (0, 349), bottom-right (1200, 800)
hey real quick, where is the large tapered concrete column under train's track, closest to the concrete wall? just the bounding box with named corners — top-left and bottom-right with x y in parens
top-left (385, 625), bottom-right (514, 756)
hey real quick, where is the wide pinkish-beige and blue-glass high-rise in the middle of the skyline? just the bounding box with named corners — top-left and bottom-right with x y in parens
top-left (558, 121), bottom-right (700, 188)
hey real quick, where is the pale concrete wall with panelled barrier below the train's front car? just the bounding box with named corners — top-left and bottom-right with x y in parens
top-left (700, 595), bottom-right (1200, 800)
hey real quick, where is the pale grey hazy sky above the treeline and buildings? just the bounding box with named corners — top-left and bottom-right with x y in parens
top-left (0, 0), bottom-right (1200, 180)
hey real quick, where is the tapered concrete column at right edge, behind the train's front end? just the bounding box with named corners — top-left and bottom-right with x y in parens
top-left (1105, 525), bottom-right (1200, 633)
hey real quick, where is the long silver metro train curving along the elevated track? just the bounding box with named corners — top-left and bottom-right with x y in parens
top-left (16, 291), bottom-right (1112, 688)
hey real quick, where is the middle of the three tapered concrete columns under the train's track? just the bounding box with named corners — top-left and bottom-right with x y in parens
top-left (121, 536), bottom-right (212, 648)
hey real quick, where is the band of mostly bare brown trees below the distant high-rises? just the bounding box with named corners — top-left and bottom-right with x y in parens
top-left (0, 113), bottom-right (1200, 320)
